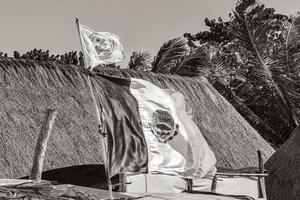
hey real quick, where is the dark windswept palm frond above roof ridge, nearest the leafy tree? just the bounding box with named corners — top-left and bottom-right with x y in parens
top-left (152, 37), bottom-right (190, 73)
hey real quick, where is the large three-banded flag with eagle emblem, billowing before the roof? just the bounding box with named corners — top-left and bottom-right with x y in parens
top-left (95, 76), bottom-right (216, 178)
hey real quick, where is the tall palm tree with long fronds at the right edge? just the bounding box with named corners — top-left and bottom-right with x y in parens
top-left (233, 2), bottom-right (300, 139)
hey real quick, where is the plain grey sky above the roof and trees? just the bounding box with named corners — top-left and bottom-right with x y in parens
top-left (0, 0), bottom-right (300, 66)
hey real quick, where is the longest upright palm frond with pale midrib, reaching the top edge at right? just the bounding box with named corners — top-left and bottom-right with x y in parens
top-left (234, 3), bottom-right (295, 128)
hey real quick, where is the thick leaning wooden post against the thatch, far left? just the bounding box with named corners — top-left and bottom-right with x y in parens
top-left (29, 109), bottom-right (57, 180)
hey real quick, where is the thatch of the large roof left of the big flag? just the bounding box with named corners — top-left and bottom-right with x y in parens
top-left (0, 57), bottom-right (102, 178)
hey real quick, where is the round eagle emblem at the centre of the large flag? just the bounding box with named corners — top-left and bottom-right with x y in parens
top-left (150, 110), bottom-right (179, 143)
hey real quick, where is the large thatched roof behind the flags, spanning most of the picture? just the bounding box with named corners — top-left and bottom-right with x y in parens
top-left (0, 58), bottom-right (274, 178)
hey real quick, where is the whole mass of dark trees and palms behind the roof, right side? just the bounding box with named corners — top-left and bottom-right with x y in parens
top-left (152, 0), bottom-right (300, 144)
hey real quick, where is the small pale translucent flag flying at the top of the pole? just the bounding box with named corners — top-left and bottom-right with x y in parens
top-left (78, 23), bottom-right (125, 68)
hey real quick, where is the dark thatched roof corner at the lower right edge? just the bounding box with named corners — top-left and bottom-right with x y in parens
top-left (265, 126), bottom-right (300, 200)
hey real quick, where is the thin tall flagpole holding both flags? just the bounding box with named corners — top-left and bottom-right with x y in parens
top-left (76, 18), bottom-right (114, 200)
